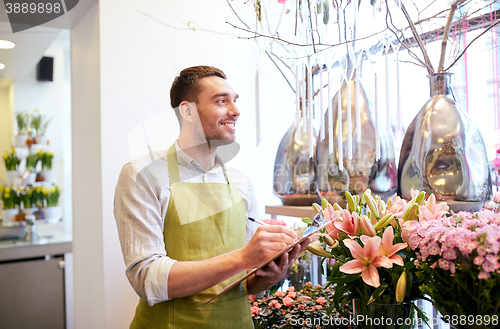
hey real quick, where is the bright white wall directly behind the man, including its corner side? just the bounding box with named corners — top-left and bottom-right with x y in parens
top-left (72, 0), bottom-right (295, 329)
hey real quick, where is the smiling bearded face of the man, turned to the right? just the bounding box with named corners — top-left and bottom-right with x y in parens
top-left (196, 76), bottom-right (240, 146)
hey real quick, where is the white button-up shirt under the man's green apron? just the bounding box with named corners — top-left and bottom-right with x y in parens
top-left (114, 141), bottom-right (259, 306)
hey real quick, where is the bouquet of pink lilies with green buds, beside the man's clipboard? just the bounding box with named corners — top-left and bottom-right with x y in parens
top-left (303, 190), bottom-right (442, 320)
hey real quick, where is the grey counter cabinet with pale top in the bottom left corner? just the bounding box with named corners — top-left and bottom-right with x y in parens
top-left (0, 228), bottom-right (72, 329)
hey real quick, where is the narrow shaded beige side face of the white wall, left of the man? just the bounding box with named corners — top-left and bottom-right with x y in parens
top-left (71, 4), bottom-right (105, 329)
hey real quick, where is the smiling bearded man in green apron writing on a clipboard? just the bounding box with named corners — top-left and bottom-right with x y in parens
top-left (114, 66), bottom-right (310, 329)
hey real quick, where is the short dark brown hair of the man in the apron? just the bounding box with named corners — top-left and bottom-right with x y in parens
top-left (170, 66), bottom-right (227, 123)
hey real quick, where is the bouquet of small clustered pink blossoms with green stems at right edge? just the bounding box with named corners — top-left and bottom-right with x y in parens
top-left (407, 210), bottom-right (500, 328)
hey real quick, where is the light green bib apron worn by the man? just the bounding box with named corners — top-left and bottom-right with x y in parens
top-left (130, 145), bottom-right (254, 329)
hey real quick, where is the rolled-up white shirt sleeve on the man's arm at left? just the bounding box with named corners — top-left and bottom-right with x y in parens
top-left (114, 161), bottom-right (175, 306)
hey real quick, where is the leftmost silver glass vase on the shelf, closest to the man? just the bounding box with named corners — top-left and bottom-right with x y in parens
top-left (273, 113), bottom-right (321, 206)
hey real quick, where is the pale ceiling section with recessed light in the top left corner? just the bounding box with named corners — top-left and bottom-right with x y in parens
top-left (0, 0), bottom-right (98, 88)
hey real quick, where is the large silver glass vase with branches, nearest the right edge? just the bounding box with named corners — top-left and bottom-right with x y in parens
top-left (398, 73), bottom-right (492, 212)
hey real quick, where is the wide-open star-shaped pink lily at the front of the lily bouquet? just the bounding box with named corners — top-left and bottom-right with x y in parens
top-left (339, 235), bottom-right (392, 288)
